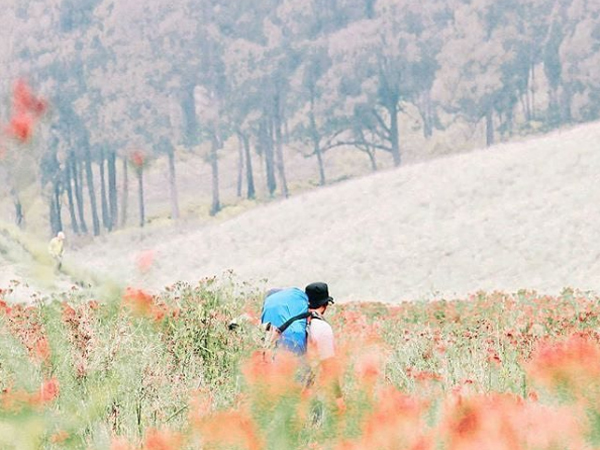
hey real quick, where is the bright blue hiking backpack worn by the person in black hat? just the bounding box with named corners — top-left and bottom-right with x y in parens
top-left (260, 288), bottom-right (321, 355)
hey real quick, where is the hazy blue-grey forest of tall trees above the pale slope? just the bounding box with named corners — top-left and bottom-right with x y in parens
top-left (0, 0), bottom-right (600, 235)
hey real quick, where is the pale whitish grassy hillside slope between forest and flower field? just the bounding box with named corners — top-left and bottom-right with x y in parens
top-left (72, 124), bottom-right (600, 302)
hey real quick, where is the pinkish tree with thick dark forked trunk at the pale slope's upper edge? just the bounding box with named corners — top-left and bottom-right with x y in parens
top-left (328, 0), bottom-right (436, 166)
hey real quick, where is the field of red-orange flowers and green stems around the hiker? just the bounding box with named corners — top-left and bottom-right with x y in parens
top-left (0, 279), bottom-right (600, 450)
